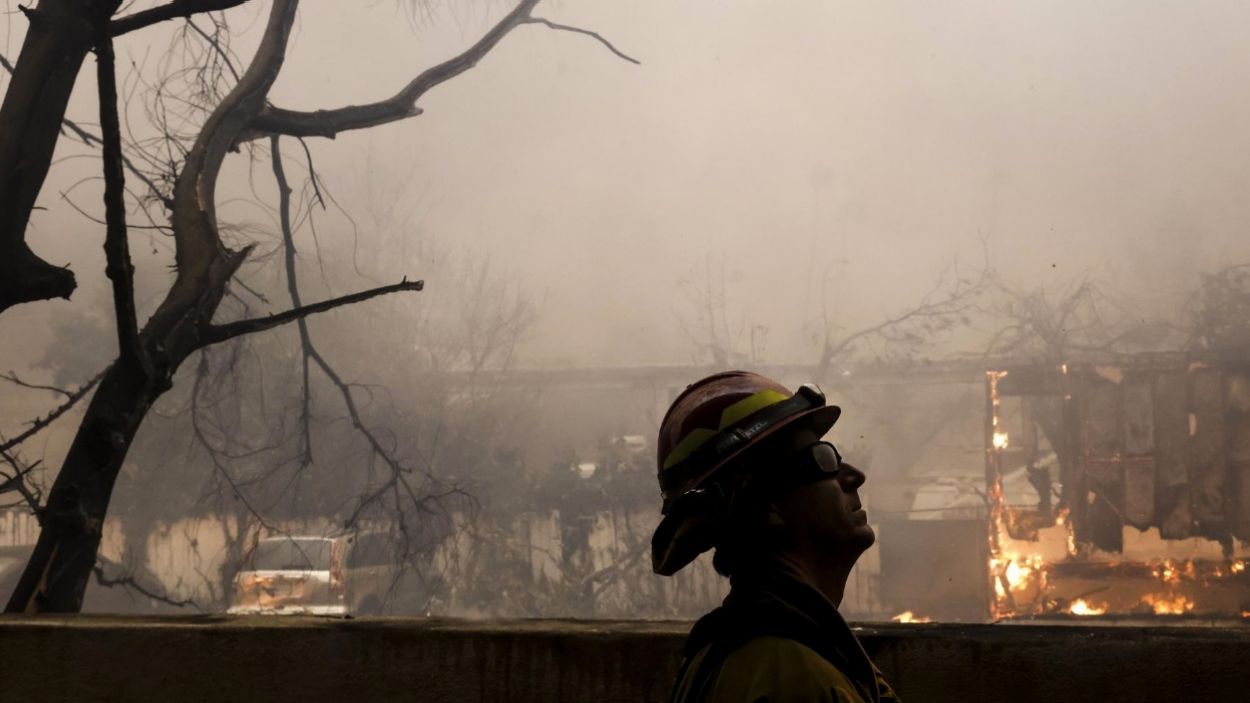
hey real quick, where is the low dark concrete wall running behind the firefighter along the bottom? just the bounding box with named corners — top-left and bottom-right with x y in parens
top-left (0, 615), bottom-right (1250, 703)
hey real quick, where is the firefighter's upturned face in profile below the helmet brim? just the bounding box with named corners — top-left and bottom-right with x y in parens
top-left (775, 429), bottom-right (876, 562)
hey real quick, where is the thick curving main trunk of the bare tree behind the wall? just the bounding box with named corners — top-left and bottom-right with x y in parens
top-left (7, 0), bottom-right (299, 613)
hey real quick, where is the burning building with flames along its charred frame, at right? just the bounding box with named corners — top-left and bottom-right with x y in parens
top-left (881, 353), bottom-right (1250, 622)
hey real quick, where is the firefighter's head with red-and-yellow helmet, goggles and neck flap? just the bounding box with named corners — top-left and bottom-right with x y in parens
top-left (651, 372), bottom-right (874, 577)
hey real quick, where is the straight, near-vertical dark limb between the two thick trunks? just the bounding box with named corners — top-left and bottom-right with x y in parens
top-left (95, 33), bottom-right (148, 373)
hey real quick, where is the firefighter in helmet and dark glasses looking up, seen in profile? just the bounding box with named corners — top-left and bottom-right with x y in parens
top-left (651, 372), bottom-right (896, 703)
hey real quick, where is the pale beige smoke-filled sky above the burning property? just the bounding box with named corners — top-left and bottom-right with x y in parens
top-left (7, 0), bottom-right (1250, 367)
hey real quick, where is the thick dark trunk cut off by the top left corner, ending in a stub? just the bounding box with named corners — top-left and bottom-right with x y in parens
top-left (0, 0), bottom-right (121, 313)
